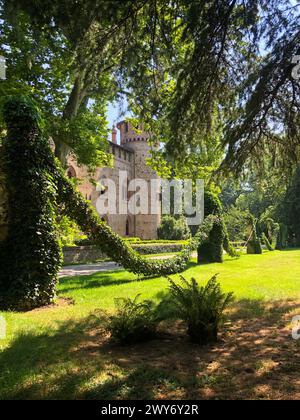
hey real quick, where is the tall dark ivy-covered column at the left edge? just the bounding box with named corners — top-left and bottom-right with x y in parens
top-left (0, 97), bottom-right (61, 311)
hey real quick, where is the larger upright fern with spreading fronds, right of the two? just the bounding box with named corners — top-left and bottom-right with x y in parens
top-left (169, 276), bottom-right (233, 344)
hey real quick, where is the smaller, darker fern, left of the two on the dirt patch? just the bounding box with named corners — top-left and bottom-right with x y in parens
top-left (106, 295), bottom-right (158, 344)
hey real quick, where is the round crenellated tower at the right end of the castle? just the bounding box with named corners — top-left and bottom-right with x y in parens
top-left (117, 121), bottom-right (161, 239)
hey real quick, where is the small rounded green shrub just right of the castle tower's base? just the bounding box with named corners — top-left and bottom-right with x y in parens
top-left (157, 216), bottom-right (191, 241)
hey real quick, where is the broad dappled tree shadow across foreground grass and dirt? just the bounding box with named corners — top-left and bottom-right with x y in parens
top-left (0, 300), bottom-right (300, 400)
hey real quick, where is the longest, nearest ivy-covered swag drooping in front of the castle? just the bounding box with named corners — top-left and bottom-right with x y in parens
top-left (49, 156), bottom-right (216, 276)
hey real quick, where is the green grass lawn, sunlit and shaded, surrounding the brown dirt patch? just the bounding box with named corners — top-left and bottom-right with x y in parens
top-left (0, 250), bottom-right (300, 399)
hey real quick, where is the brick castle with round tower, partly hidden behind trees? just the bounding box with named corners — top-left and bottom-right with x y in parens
top-left (67, 121), bottom-right (161, 239)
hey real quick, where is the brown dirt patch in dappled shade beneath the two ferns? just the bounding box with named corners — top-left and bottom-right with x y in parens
top-left (74, 301), bottom-right (300, 400)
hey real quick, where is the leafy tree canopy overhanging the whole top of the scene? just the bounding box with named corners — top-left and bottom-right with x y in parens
top-left (0, 0), bottom-right (300, 174)
